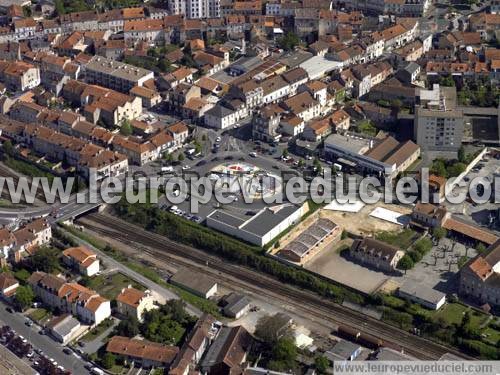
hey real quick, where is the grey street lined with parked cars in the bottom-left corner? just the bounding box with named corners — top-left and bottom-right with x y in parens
top-left (0, 302), bottom-right (88, 374)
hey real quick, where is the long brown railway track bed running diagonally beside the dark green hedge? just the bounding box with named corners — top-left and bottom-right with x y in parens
top-left (80, 214), bottom-right (472, 360)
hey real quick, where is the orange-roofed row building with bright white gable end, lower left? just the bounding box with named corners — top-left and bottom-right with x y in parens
top-left (28, 272), bottom-right (111, 326)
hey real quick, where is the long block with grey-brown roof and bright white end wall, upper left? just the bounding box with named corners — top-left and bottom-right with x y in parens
top-left (85, 56), bottom-right (154, 93)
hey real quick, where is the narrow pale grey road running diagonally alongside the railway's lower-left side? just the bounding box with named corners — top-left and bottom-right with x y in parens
top-left (63, 230), bottom-right (202, 317)
